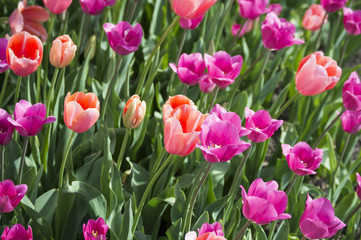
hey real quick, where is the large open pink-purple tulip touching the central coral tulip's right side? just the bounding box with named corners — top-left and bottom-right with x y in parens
top-left (197, 114), bottom-right (251, 163)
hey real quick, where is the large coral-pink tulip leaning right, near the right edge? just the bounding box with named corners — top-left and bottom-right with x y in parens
top-left (296, 51), bottom-right (342, 96)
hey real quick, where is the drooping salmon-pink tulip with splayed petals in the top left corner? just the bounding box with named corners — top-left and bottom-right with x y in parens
top-left (9, 0), bottom-right (48, 42)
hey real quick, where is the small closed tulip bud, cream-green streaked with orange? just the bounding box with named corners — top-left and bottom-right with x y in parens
top-left (123, 95), bottom-right (147, 129)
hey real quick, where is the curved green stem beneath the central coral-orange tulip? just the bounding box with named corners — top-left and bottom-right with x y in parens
top-left (132, 155), bottom-right (173, 235)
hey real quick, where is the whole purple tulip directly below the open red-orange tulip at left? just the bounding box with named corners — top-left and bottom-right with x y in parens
top-left (8, 100), bottom-right (56, 137)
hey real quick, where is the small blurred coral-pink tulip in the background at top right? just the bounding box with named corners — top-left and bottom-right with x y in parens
top-left (302, 3), bottom-right (326, 31)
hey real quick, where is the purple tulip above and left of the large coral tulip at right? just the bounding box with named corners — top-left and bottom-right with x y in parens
top-left (261, 12), bottom-right (304, 51)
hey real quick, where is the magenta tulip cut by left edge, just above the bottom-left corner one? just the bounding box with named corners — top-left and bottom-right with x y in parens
top-left (0, 179), bottom-right (28, 213)
